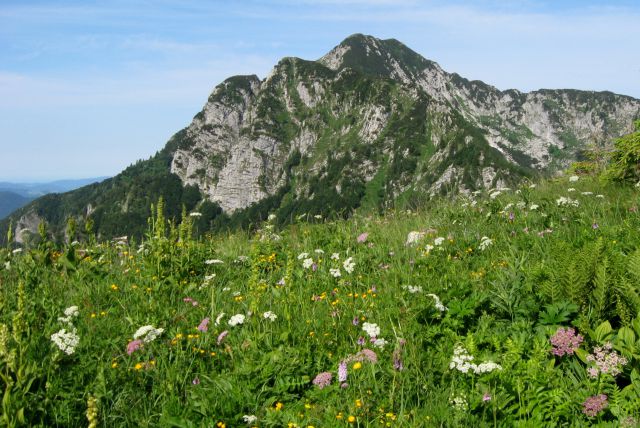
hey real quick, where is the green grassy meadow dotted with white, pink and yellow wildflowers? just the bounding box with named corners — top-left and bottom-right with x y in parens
top-left (0, 177), bottom-right (640, 427)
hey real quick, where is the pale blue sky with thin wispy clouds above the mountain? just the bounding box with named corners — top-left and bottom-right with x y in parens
top-left (0, 0), bottom-right (640, 181)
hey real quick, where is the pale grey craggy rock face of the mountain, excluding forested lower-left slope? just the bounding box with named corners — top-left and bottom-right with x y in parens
top-left (166, 35), bottom-right (640, 213)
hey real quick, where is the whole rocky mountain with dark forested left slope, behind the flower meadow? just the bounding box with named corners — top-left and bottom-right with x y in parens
top-left (4, 34), bottom-right (640, 240)
